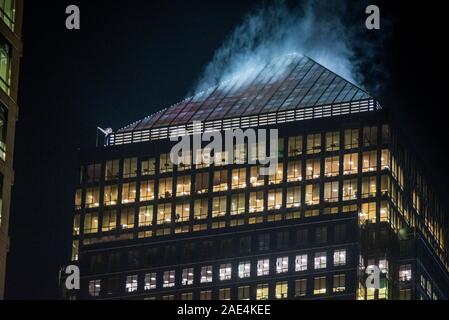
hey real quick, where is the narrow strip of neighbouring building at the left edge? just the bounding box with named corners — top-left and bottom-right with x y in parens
top-left (0, 0), bottom-right (23, 299)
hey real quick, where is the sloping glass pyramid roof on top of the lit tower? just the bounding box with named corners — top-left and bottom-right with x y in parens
top-left (118, 54), bottom-right (373, 133)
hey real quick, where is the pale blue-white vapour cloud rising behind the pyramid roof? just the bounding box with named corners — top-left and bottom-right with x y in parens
top-left (194, 0), bottom-right (364, 93)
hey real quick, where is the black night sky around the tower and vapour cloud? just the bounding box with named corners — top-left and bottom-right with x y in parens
top-left (6, 0), bottom-right (449, 299)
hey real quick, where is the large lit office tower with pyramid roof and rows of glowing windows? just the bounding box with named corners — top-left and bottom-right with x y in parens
top-left (71, 54), bottom-right (449, 300)
